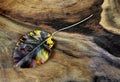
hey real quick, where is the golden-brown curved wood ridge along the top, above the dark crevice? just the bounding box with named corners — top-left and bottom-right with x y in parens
top-left (0, 0), bottom-right (96, 25)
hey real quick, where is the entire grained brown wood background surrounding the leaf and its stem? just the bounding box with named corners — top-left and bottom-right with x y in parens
top-left (0, 0), bottom-right (120, 82)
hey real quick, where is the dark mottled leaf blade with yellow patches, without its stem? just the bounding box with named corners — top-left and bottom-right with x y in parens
top-left (13, 30), bottom-right (54, 68)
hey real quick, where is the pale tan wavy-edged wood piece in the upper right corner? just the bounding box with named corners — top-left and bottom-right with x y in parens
top-left (100, 0), bottom-right (120, 34)
